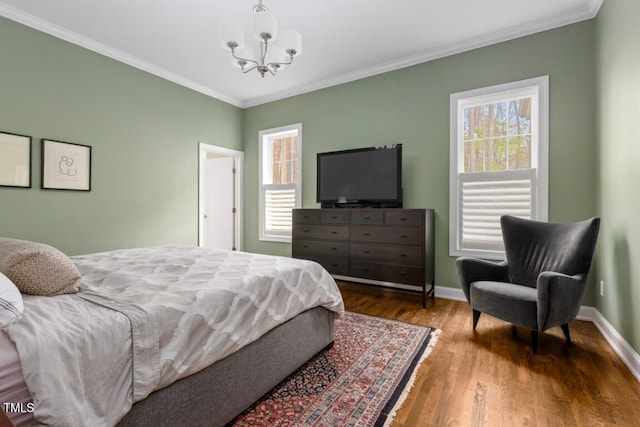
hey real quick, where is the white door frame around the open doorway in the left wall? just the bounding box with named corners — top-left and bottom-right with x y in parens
top-left (198, 142), bottom-right (244, 251)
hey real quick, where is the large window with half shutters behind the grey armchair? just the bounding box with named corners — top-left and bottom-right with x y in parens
top-left (449, 76), bottom-right (549, 259)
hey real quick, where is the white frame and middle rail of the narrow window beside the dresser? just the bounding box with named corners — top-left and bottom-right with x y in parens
top-left (258, 123), bottom-right (302, 243)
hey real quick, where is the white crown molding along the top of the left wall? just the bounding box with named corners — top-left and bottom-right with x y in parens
top-left (0, 3), bottom-right (242, 108)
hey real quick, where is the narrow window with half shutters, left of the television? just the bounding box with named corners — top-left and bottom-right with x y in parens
top-left (259, 124), bottom-right (302, 242)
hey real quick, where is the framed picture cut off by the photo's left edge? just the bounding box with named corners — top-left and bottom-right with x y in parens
top-left (0, 132), bottom-right (31, 188)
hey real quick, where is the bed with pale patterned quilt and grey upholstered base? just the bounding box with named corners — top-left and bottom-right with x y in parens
top-left (0, 239), bottom-right (344, 426)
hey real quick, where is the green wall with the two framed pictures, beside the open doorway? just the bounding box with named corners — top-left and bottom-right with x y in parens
top-left (0, 18), bottom-right (242, 254)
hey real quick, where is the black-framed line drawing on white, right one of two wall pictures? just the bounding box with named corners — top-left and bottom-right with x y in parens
top-left (42, 139), bottom-right (91, 191)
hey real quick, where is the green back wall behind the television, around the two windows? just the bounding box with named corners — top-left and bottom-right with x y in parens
top-left (242, 20), bottom-right (597, 304)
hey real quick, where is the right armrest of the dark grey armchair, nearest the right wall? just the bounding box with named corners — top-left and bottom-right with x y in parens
top-left (537, 271), bottom-right (587, 331)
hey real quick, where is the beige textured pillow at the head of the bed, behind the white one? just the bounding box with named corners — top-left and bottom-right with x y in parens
top-left (0, 238), bottom-right (80, 296)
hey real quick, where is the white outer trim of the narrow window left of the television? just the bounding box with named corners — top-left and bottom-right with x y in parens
top-left (258, 123), bottom-right (302, 243)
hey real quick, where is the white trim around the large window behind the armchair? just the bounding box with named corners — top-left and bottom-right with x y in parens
top-left (449, 76), bottom-right (549, 259)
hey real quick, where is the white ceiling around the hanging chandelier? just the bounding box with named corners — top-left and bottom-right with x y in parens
top-left (0, 0), bottom-right (603, 107)
